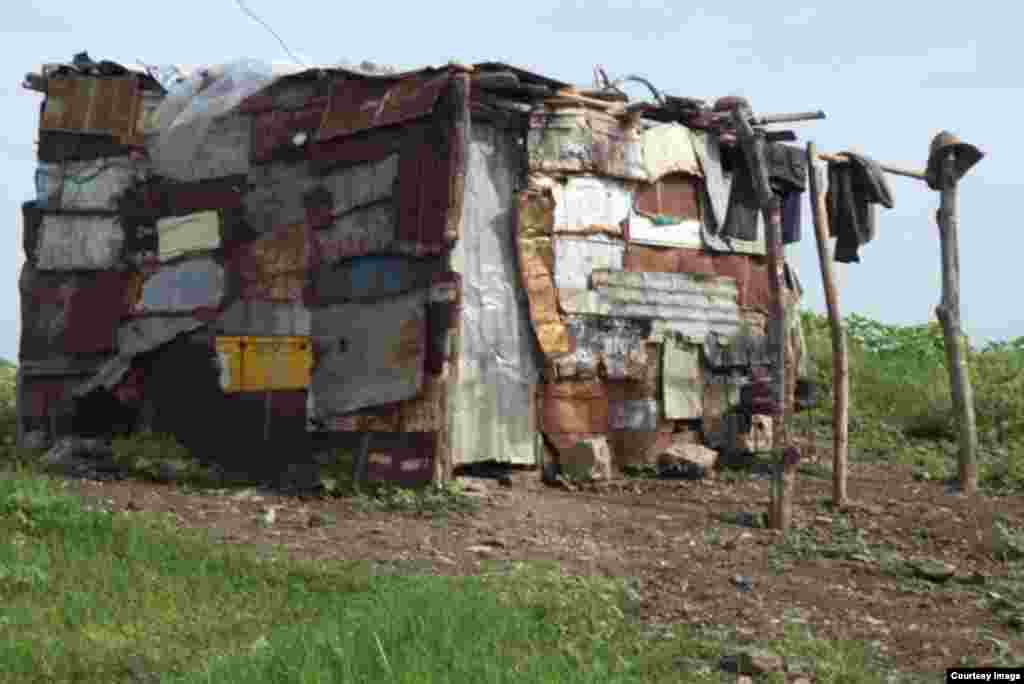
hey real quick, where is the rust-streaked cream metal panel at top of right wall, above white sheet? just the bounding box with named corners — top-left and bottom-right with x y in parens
top-left (526, 106), bottom-right (647, 180)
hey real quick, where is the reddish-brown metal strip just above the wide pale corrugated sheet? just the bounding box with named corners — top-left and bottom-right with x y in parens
top-left (623, 246), bottom-right (771, 311)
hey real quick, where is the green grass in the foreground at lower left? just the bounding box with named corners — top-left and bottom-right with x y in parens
top-left (0, 471), bottom-right (913, 684)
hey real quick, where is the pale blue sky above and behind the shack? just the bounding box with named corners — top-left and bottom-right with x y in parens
top-left (0, 0), bottom-right (1024, 359)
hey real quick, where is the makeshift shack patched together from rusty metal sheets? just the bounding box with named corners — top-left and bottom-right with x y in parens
top-left (18, 54), bottom-right (806, 482)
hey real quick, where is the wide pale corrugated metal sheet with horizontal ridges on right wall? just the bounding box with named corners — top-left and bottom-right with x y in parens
top-left (559, 271), bottom-right (739, 341)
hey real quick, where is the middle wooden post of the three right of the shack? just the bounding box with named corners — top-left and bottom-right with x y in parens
top-left (807, 142), bottom-right (850, 508)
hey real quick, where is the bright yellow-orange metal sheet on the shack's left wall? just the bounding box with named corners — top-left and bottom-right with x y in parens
top-left (214, 337), bottom-right (313, 392)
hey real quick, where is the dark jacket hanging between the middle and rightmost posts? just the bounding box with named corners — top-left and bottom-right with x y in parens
top-left (825, 152), bottom-right (893, 263)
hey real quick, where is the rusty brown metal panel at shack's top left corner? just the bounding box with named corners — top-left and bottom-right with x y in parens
top-left (39, 76), bottom-right (141, 144)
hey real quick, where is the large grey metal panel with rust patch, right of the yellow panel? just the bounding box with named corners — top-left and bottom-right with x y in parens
top-left (310, 290), bottom-right (427, 418)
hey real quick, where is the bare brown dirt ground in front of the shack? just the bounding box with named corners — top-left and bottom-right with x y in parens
top-left (68, 456), bottom-right (1024, 673)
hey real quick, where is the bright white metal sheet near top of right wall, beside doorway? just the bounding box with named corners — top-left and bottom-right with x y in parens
top-left (551, 176), bottom-right (633, 236)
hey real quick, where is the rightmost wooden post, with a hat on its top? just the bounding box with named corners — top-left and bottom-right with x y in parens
top-left (935, 152), bottom-right (978, 494)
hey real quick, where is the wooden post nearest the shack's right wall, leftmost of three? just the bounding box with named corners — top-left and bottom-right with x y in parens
top-left (732, 108), bottom-right (798, 529)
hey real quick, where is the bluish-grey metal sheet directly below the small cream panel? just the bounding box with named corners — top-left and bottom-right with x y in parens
top-left (136, 257), bottom-right (224, 313)
